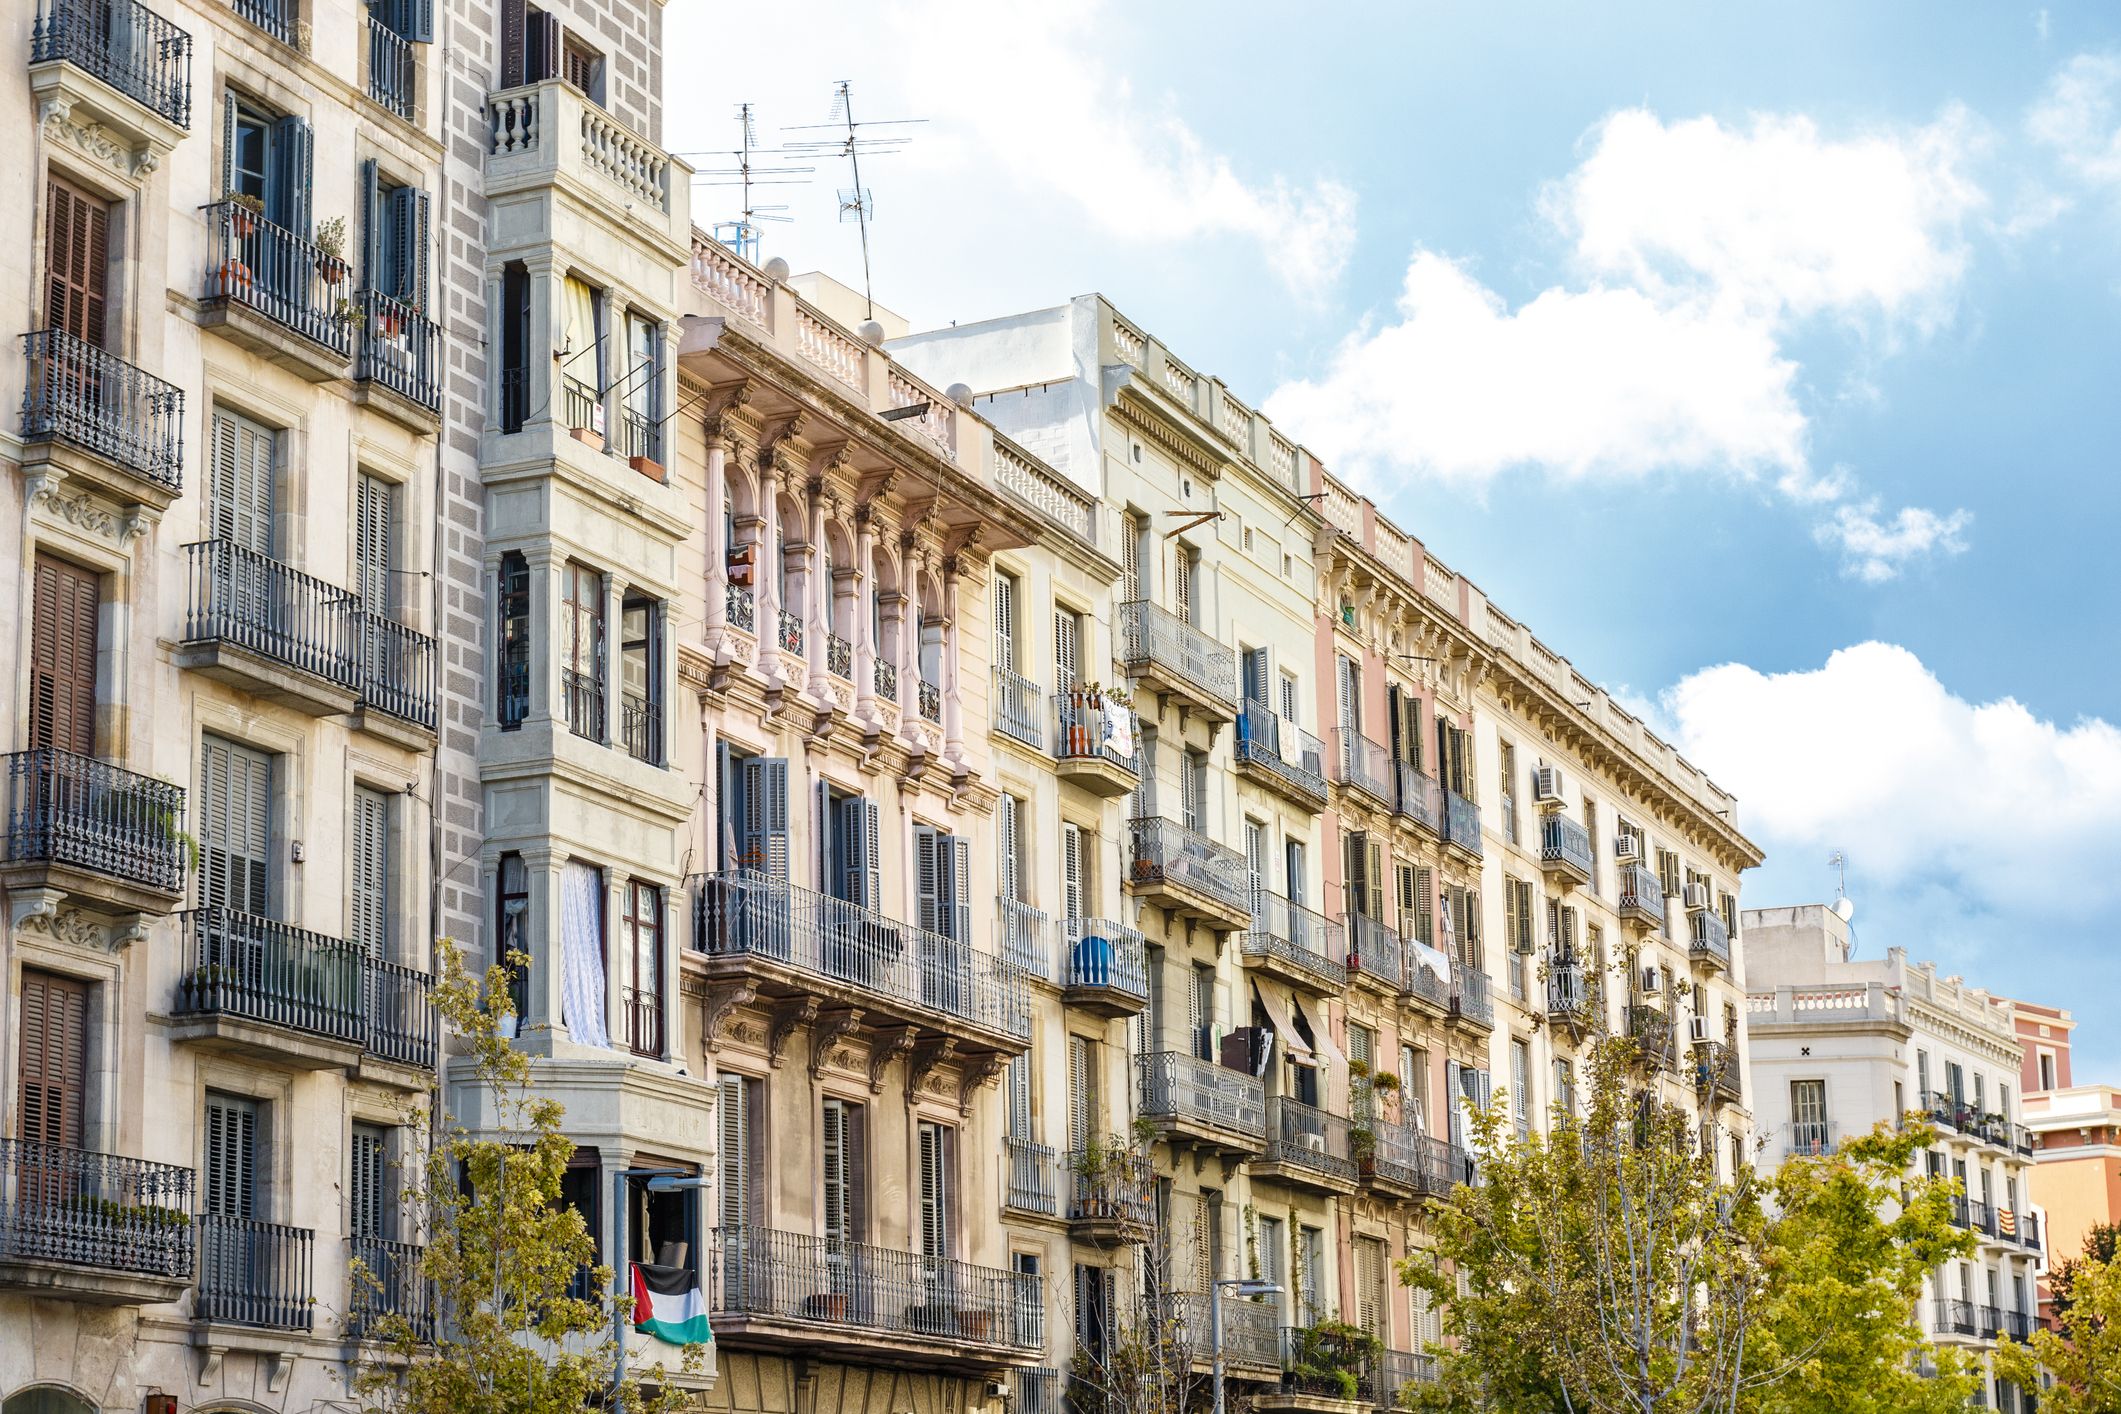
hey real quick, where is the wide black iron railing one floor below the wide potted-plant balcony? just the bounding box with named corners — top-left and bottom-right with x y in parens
top-left (185, 541), bottom-right (361, 689)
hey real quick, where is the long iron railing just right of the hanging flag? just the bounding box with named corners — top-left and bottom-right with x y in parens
top-left (708, 1227), bottom-right (1044, 1350)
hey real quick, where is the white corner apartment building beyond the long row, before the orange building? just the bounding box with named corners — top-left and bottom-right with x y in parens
top-left (1743, 903), bottom-right (2045, 1410)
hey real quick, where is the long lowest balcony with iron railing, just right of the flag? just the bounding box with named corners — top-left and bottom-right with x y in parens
top-left (708, 1227), bottom-right (1044, 1367)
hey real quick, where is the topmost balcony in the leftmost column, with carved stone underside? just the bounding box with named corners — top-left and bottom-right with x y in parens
top-left (30, 0), bottom-right (191, 173)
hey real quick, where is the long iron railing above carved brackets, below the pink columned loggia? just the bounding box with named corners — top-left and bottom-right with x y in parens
top-left (694, 869), bottom-right (1031, 1039)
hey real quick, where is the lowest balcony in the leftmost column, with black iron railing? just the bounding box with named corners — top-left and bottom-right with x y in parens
top-left (0, 1138), bottom-right (193, 1306)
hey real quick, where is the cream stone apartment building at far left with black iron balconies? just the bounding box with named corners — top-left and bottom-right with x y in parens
top-left (0, 0), bottom-right (443, 1410)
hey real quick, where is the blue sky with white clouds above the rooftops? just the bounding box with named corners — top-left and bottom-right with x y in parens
top-left (666, 0), bottom-right (2121, 1083)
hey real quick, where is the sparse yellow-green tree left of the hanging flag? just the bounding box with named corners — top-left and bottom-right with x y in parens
top-left (354, 939), bottom-right (700, 1414)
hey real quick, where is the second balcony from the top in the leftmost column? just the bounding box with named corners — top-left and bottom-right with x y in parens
top-left (21, 329), bottom-right (185, 511)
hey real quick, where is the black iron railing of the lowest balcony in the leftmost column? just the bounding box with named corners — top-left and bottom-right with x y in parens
top-left (0, 1138), bottom-right (193, 1280)
